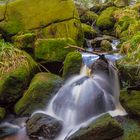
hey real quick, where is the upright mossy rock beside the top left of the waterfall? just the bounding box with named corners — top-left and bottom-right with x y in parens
top-left (63, 52), bottom-right (82, 79)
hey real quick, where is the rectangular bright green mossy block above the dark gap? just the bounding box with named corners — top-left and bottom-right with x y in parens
top-left (35, 38), bottom-right (76, 62)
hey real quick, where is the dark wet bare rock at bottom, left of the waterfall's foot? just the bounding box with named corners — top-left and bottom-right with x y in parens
top-left (26, 113), bottom-right (62, 140)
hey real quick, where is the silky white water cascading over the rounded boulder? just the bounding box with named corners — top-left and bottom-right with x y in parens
top-left (45, 55), bottom-right (125, 140)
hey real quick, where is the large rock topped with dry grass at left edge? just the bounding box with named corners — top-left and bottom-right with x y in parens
top-left (0, 41), bottom-right (38, 107)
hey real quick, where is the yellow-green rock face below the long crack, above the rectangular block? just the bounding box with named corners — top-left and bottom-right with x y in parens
top-left (41, 19), bottom-right (84, 46)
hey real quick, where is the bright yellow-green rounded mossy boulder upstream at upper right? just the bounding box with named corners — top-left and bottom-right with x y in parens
top-left (96, 7), bottom-right (117, 30)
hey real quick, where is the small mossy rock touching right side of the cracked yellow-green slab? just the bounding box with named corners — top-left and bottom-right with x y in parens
top-left (82, 23), bottom-right (97, 39)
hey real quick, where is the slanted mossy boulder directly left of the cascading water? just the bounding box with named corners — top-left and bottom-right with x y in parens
top-left (14, 73), bottom-right (63, 115)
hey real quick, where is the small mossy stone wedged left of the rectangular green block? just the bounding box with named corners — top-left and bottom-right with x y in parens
top-left (12, 33), bottom-right (36, 50)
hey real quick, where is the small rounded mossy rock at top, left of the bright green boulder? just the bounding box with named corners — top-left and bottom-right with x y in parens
top-left (80, 11), bottom-right (98, 25)
